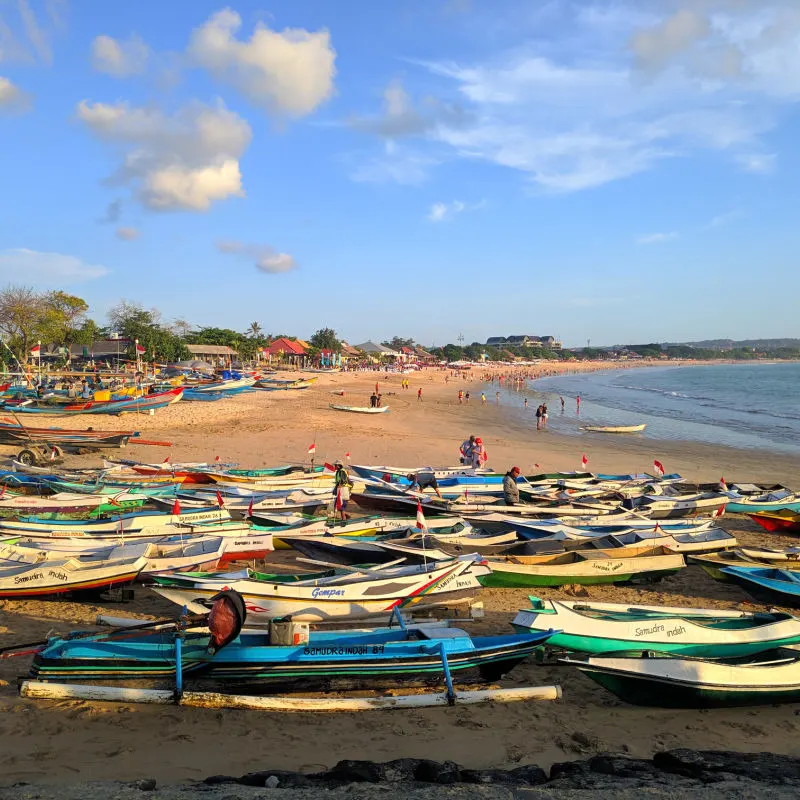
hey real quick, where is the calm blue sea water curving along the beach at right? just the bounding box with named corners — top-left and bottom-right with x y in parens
top-left (502, 363), bottom-right (800, 454)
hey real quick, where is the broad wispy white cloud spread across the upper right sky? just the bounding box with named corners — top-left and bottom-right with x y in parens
top-left (354, 0), bottom-right (800, 192)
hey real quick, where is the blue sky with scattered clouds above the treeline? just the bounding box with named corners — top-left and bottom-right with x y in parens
top-left (0, 0), bottom-right (800, 346)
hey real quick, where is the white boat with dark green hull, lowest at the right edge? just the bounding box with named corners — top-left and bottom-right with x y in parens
top-left (560, 650), bottom-right (800, 708)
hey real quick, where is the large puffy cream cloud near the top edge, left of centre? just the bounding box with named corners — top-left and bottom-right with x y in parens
top-left (188, 8), bottom-right (336, 117)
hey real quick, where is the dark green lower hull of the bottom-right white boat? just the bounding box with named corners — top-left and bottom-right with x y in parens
top-left (581, 669), bottom-right (800, 708)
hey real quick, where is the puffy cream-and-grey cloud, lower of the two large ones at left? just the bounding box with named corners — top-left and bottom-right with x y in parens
top-left (78, 101), bottom-right (251, 211)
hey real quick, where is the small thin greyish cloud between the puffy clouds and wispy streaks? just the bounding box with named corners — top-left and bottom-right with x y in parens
top-left (349, 81), bottom-right (467, 139)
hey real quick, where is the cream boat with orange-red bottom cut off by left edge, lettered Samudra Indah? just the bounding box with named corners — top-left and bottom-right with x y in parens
top-left (0, 557), bottom-right (147, 597)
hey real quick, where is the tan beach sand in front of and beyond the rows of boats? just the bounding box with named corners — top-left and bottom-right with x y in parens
top-left (0, 371), bottom-right (800, 784)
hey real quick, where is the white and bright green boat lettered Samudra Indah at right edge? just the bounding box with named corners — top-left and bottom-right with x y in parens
top-left (511, 597), bottom-right (800, 658)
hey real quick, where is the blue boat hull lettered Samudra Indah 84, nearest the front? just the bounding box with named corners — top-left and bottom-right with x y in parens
top-left (30, 625), bottom-right (550, 684)
